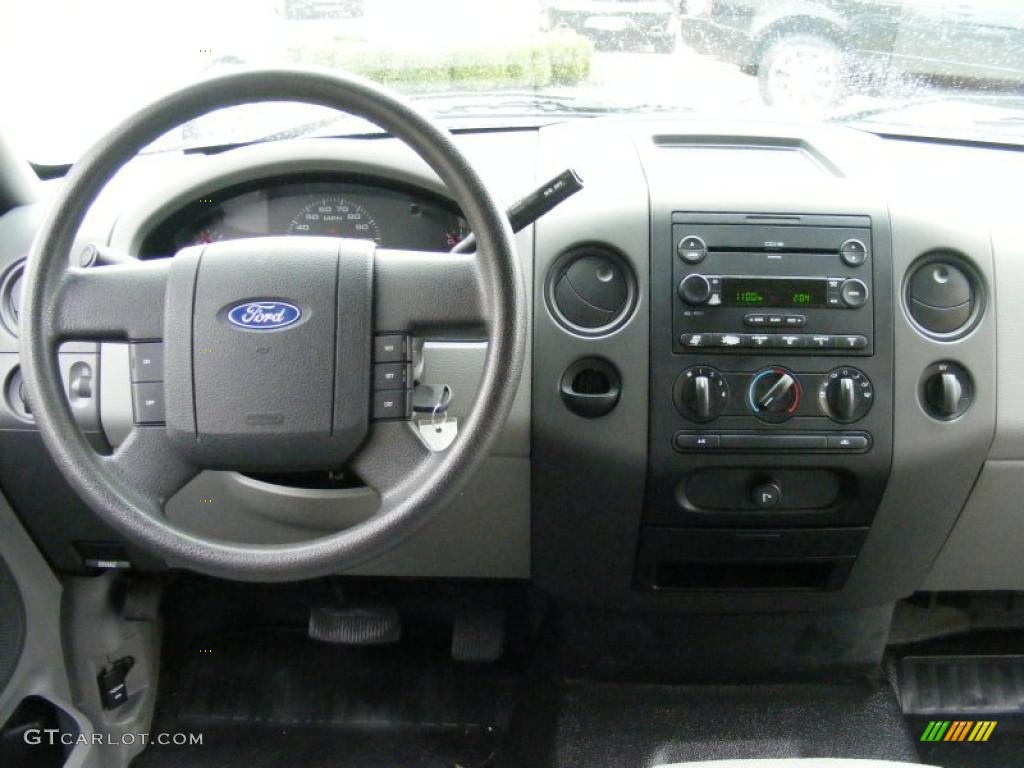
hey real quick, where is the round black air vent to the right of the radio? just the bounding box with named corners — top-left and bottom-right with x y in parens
top-left (905, 252), bottom-right (983, 339)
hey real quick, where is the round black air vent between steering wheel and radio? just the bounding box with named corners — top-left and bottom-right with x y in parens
top-left (548, 246), bottom-right (637, 336)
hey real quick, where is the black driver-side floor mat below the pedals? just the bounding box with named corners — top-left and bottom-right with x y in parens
top-left (133, 631), bottom-right (515, 768)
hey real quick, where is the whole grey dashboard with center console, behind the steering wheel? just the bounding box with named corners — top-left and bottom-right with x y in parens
top-left (0, 119), bottom-right (1024, 612)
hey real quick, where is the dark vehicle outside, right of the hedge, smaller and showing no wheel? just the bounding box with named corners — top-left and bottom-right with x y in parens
top-left (544, 0), bottom-right (679, 53)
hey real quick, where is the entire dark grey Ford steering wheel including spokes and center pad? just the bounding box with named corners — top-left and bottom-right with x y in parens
top-left (20, 70), bottom-right (526, 581)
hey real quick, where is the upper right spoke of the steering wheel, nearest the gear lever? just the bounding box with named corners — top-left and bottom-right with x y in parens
top-left (374, 248), bottom-right (488, 336)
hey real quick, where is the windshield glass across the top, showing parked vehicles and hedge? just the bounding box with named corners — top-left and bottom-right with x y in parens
top-left (0, 0), bottom-right (1024, 164)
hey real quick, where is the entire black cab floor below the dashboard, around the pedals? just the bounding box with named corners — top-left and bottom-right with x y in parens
top-left (133, 581), bottom-right (929, 768)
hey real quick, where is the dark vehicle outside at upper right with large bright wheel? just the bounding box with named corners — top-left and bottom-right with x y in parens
top-left (682, 0), bottom-right (1024, 108)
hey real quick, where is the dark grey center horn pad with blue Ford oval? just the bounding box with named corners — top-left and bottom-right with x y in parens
top-left (164, 238), bottom-right (374, 470)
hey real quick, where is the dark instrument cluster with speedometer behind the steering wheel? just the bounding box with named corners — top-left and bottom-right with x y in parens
top-left (139, 175), bottom-right (469, 259)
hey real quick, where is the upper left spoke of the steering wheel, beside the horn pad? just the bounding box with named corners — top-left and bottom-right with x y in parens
top-left (51, 259), bottom-right (171, 340)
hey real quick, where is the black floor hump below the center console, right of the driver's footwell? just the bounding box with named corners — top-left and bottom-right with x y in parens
top-left (555, 682), bottom-right (916, 768)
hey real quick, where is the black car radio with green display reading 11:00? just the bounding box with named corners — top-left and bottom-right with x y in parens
top-left (672, 213), bottom-right (873, 355)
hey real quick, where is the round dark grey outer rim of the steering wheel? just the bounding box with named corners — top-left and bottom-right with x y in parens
top-left (20, 70), bottom-right (526, 581)
